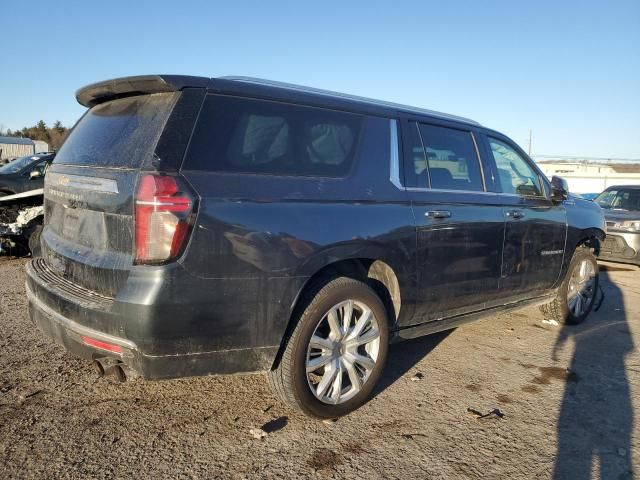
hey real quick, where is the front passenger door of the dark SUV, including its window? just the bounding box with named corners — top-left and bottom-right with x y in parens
top-left (483, 133), bottom-right (567, 298)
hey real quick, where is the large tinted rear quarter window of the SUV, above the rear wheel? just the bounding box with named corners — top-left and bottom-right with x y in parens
top-left (184, 95), bottom-right (364, 177)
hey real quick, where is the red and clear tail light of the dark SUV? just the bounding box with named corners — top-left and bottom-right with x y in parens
top-left (135, 175), bottom-right (195, 264)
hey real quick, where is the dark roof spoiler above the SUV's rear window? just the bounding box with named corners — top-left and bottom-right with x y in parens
top-left (76, 75), bottom-right (209, 108)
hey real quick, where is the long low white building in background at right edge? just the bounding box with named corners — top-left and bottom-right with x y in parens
top-left (536, 159), bottom-right (640, 193)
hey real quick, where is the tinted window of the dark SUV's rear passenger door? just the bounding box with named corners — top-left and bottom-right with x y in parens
top-left (407, 124), bottom-right (484, 191)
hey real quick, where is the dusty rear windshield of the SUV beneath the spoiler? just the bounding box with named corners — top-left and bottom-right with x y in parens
top-left (53, 93), bottom-right (179, 168)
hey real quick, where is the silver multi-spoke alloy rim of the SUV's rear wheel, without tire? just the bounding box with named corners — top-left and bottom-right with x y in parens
top-left (306, 300), bottom-right (380, 405)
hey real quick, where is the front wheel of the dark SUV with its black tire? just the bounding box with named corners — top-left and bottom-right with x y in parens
top-left (540, 246), bottom-right (599, 325)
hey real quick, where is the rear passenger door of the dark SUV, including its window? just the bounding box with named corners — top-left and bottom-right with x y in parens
top-left (403, 121), bottom-right (504, 323)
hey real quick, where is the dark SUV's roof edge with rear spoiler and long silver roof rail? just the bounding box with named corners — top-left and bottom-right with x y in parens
top-left (76, 75), bottom-right (479, 126)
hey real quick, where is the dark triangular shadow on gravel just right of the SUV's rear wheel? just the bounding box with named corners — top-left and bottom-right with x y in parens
top-left (373, 330), bottom-right (453, 397)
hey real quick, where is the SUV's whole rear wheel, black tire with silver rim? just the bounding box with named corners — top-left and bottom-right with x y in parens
top-left (268, 277), bottom-right (389, 418)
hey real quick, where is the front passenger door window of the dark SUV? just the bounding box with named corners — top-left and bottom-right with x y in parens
top-left (489, 137), bottom-right (544, 197)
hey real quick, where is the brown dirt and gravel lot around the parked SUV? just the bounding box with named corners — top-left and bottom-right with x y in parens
top-left (0, 260), bottom-right (640, 479)
